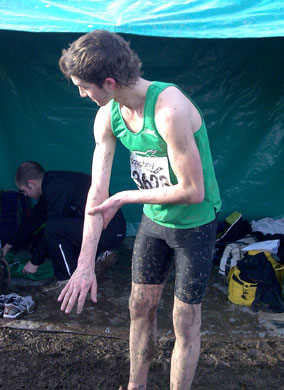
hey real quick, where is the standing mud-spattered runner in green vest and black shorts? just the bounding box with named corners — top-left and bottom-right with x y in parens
top-left (58, 30), bottom-right (221, 390)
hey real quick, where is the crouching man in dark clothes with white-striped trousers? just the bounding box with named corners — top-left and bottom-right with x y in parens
top-left (3, 161), bottom-right (126, 289)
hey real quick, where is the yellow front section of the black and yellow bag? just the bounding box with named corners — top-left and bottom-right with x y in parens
top-left (228, 266), bottom-right (257, 306)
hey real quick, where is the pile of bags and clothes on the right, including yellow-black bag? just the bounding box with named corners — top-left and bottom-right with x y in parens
top-left (216, 212), bottom-right (284, 313)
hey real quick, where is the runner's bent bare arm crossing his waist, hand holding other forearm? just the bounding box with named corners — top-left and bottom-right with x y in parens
top-left (90, 87), bottom-right (204, 226)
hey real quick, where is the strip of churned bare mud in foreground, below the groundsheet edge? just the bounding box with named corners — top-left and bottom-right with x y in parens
top-left (0, 328), bottom-right (284, 390)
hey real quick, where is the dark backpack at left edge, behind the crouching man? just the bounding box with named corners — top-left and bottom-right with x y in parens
top-left (0, 190), bottom-right (31, 247)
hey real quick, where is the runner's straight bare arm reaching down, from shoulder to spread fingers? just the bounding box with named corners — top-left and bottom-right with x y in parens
top-left (58, 106), bottom-right (116, 314)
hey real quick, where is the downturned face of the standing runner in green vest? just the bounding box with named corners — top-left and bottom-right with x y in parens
top-left (71, 76), bottom-right (113, 106)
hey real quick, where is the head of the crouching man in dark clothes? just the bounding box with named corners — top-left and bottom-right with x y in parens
top-left (15, 161), bottom-right (45, 199)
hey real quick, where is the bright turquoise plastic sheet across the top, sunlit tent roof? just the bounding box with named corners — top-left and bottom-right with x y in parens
top-left (0, 0), bottom-right (284, 38)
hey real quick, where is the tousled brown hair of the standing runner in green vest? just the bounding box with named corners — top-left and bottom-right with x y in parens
top-left (59, 30), bottom-right (142, 88)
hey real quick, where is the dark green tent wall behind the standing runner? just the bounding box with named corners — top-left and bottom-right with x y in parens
top-left (0, 1), bottom-right (284, 235)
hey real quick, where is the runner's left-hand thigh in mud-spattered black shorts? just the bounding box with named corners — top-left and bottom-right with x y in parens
top-left (132, 215), bottom-right (173, 284)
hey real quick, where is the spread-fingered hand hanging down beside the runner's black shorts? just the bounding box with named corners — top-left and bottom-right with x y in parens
top-left (58, 268), bottom-right (97, 314)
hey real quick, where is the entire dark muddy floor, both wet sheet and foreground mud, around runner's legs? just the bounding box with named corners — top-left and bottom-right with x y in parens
top-left (0, 241), bottom-right (284, 390)
